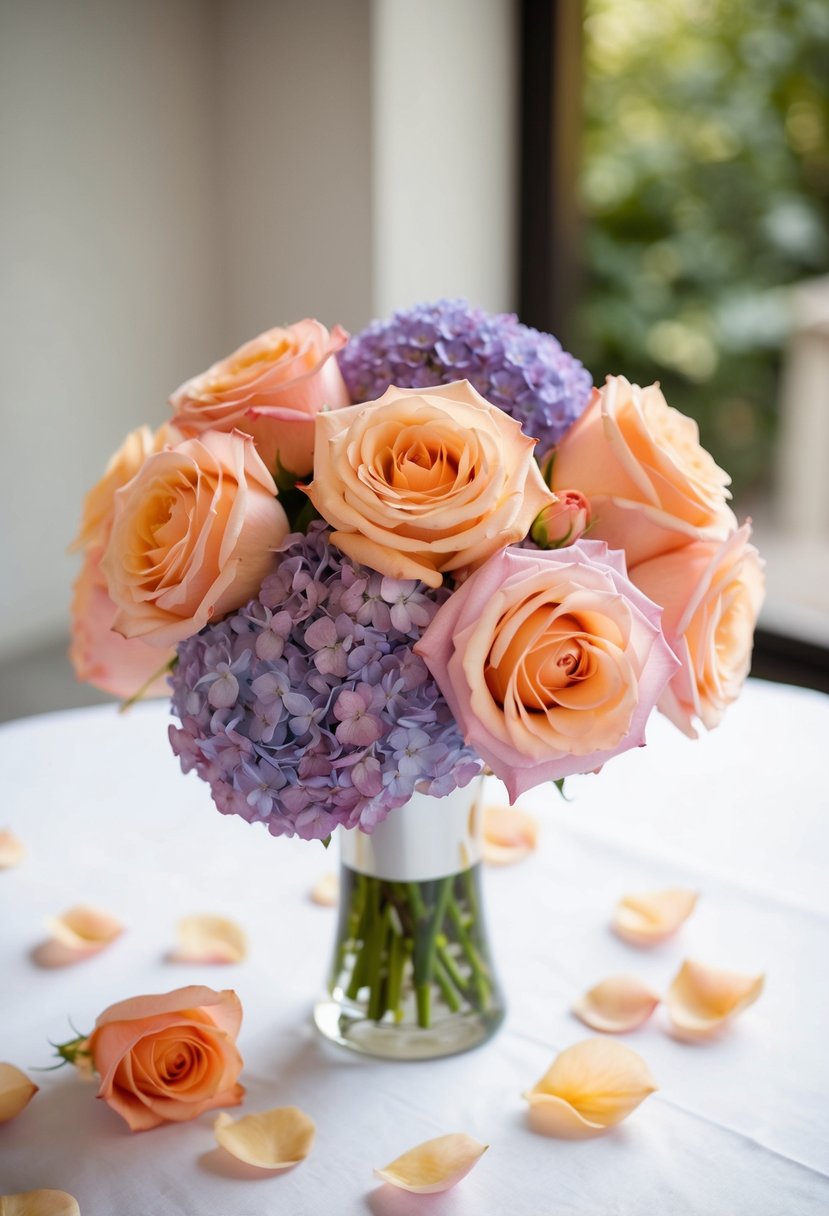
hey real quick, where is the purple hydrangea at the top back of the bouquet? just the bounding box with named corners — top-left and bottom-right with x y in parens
top-left (338, 300), bottom-right (592, 458)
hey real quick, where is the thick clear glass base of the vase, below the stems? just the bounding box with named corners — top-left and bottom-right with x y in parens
top-left (314, 995), bottom-right (503, 1060)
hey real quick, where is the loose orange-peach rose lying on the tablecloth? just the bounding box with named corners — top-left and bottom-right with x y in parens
top-left (85, 986), bottom-right (244, 1132)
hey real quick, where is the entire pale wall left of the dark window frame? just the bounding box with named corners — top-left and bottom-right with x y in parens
top-left (0, 0), bottom-right (515, 662)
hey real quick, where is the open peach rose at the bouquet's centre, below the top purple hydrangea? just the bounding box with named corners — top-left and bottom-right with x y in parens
top-left (308, 381), bottom-right (556, 587)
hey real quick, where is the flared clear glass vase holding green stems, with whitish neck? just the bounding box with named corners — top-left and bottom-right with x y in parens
top-left (315, 779), bottom-right (504, 1059)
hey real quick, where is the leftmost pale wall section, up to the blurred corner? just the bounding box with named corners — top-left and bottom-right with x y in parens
top-left (0, 0), bottom-right (222, 655)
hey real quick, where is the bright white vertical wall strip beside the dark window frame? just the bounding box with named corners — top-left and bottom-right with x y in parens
top-left (372, 0), bottom-right (518, 316)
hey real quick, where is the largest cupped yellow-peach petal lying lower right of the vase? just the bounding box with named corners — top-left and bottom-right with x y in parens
top-left (524, 1038), bottom-right (658, 1139)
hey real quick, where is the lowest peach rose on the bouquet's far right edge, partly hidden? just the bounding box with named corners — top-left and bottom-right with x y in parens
top-left (631, 523), bottom-right (765, 738)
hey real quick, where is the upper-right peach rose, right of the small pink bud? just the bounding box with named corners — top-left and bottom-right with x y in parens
top-left (551, 376), bottom-right (737, 569)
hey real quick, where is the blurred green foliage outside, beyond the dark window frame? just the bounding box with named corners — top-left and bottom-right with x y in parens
top-left (574, 0), bottom-right (829, 495)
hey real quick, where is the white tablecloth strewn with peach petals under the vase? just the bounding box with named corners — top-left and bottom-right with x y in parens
top-left (0, 682), bottom-right (829, 1216)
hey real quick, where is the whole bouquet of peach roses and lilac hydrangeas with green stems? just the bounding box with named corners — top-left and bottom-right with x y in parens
top-left (72, 300), bottom-right (762, 1026)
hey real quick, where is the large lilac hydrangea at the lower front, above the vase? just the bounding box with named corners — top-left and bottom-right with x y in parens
top-left (170, 520), bottom-right (481, 839)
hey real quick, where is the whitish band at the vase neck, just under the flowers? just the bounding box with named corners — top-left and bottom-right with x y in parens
top-left (339, 777), bottom-right (484, 883)
